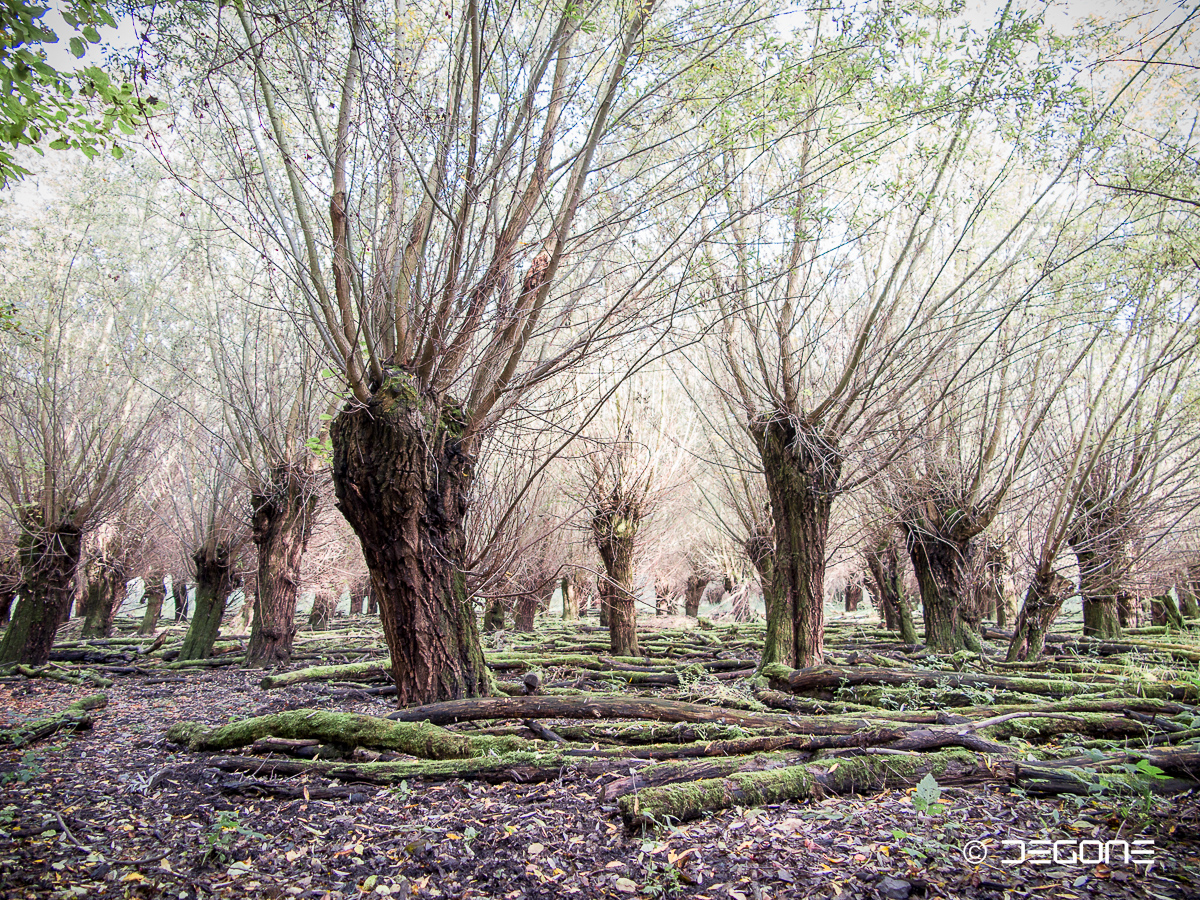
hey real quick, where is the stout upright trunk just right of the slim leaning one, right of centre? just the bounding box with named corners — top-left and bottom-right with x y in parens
top-left (904, 523), bottom-right (972, 653)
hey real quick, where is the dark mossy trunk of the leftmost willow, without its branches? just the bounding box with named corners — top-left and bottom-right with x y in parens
top-left (0, 524), bottom-right (83, 666)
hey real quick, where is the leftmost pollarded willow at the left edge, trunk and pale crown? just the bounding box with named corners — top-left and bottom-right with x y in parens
top-left (0, 160), bottom-right (171, 665)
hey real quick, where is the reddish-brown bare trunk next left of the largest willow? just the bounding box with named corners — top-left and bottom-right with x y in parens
top-left (246, 466), bottom-right (317, 666)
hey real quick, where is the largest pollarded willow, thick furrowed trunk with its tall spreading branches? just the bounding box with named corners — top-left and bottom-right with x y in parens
top-left (150, 0), bottom-right (761, 703)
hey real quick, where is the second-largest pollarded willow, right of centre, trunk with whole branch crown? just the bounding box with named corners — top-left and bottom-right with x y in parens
top-left (703, 3), bottom-right (1113, 665)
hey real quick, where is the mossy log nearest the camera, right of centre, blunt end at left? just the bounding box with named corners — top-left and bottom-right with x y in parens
top-left (619, 750), bottom-right (994, 828)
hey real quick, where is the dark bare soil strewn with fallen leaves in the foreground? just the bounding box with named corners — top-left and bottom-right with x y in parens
top-left (0, 619), bottom-right (1200, 900)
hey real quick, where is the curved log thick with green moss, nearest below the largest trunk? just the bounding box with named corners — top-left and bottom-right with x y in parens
top-left (167, 709), bottom-right (538, 760)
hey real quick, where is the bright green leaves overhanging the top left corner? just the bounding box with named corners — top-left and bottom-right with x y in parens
top-left (0, 0), bottom-right (157, 184)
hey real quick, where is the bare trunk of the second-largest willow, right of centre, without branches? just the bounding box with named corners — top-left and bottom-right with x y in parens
top-left (750, 414), bottom-right (842, 667)
